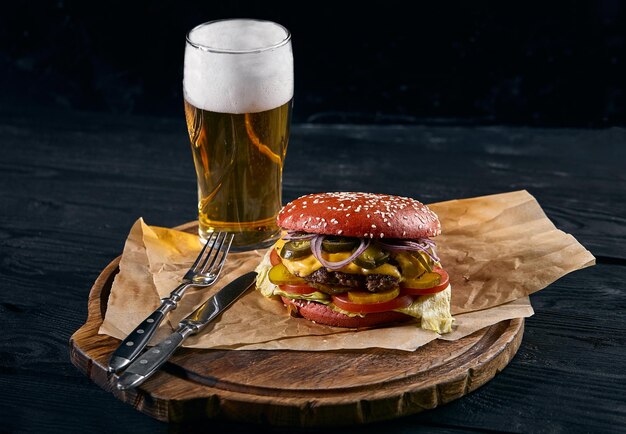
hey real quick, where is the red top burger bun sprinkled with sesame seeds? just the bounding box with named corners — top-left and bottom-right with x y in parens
top-left (277, 192), bottom-right (441, 239)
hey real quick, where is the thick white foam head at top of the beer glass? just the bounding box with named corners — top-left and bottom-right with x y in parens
top-left (183, 19), bottom-right (293, 113)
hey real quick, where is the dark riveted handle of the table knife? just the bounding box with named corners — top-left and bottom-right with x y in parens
top-left (116, 325), bottom-right (195, 390)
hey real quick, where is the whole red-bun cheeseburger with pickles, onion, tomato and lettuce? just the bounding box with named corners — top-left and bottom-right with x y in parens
top-left (257, 192), bottom-right (453, 334)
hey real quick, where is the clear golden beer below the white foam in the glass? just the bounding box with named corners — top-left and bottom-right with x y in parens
top-left (185, 97), bottom-right (292, 248)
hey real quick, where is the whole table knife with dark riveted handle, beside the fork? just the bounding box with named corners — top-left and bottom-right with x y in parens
top-left (117, 271), bottom-right (257, 390)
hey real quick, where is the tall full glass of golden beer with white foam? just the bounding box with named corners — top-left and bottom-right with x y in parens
top-left (183, 19), bottom-right (294, 251)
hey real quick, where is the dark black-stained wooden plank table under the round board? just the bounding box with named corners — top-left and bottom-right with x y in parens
top-left (0, 107), bottom-right (626, 433)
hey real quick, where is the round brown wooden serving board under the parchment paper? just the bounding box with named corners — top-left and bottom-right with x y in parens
top-left (70, 223), bottom-right (524, 426)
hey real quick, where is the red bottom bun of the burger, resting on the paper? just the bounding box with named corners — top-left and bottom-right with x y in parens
top-left (281, 297), bottom-right (414, 328)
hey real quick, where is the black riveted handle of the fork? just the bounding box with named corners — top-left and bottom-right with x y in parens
top-left (108, 285), bottom-right (188, 373)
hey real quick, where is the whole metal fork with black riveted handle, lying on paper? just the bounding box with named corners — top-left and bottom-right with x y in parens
top-left (107, 232), bottom-right (234, 373)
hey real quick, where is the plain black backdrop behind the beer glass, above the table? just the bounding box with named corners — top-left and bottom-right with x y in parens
top-left (0, 0), bottom-right (626, 127)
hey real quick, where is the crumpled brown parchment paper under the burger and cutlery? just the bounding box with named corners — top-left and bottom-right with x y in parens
top-left (99, 190), bottom-right (595, 351)
